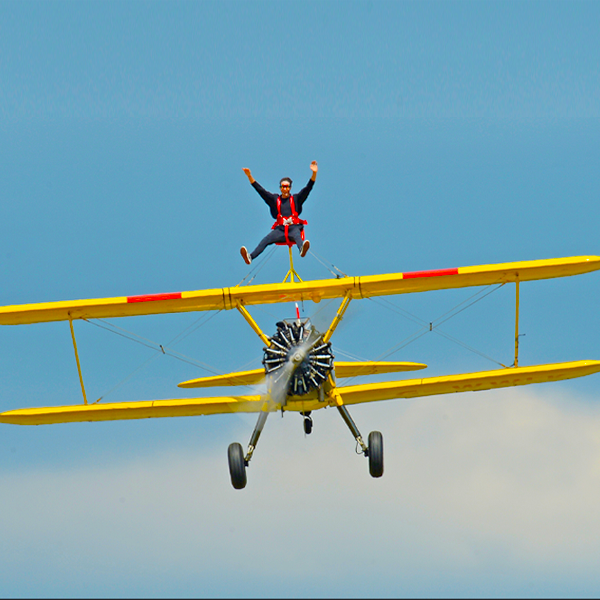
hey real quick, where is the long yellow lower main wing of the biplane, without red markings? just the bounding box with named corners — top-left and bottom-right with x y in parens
top-left (0, 360), bottom-right (600, 425)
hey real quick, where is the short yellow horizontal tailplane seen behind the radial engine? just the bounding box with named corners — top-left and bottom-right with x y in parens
top-left (177, 361), bottom-right (427, 389)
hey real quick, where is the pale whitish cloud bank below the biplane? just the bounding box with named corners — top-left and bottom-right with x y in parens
top-left (0, 386), bottom-right (600, 595)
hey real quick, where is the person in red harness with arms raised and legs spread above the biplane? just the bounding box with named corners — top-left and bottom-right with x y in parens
top-left (240, 160), bottom-right (319, 265)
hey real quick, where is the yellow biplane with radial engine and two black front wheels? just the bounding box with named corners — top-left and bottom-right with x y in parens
top-left (0, 249), bottom-right (600, 489)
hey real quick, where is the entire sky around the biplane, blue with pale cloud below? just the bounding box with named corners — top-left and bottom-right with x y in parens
top-left (0, 2), bottom-right (600, 597)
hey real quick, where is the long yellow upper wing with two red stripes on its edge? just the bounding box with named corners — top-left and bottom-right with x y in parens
top-left (0, 256), bottom-right (600, 325)
